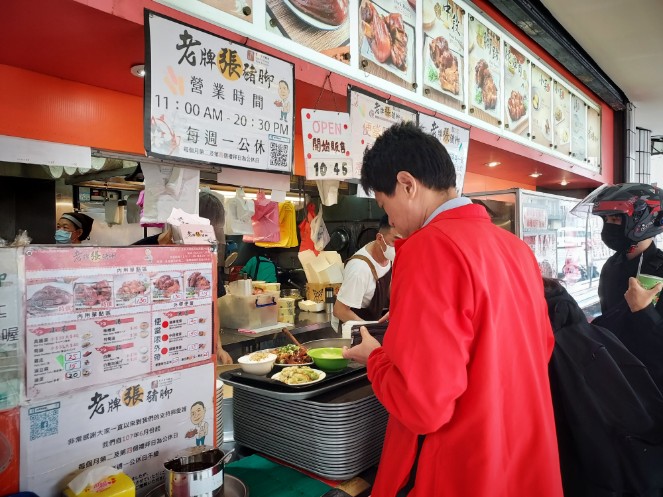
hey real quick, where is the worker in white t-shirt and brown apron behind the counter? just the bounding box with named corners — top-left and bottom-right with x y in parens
top-left (332, 215), bottom-right (400, 328)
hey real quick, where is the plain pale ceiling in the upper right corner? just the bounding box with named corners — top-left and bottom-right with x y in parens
top-left (542, 0), bottom-right (663, 135)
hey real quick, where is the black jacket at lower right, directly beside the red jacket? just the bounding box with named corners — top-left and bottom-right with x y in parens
top-left (546, 287), bottom-right (663, 497)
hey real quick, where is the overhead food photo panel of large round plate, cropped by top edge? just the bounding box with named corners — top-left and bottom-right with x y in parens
top-left (265, 0), bottom-right (350, 64)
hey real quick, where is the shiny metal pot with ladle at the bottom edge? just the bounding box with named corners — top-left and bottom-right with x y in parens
top-left (164, 445), bottom-right (233, 497)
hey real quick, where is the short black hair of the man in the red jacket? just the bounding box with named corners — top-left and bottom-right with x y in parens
top-left (361, 122), bottom-right (456, 196)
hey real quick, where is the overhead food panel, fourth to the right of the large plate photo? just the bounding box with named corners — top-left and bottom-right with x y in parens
top-left (504, 43), bottom-right (530, 136)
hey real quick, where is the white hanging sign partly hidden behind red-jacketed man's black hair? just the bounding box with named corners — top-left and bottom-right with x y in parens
top-left (348, 88), bottom-right (417, 179)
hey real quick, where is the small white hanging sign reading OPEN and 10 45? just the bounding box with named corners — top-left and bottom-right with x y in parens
top-left (302, 109), bottom-right (352, 180)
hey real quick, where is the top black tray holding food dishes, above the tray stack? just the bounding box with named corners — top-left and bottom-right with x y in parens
top-left (219, 362), bottom-right (367, 400)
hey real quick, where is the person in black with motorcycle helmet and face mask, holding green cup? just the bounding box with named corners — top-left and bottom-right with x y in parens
top-left (571, 183), bottom-right (663, 392)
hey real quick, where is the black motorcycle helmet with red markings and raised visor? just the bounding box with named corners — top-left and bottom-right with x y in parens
top-left (571, 183), bottom-right (663, 243)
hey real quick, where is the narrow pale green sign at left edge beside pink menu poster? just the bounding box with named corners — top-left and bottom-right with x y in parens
top-left (0, 248), bottom-right (23, 406)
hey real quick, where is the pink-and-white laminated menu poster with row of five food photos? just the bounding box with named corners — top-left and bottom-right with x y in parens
top-left (25, 245), bottom-right (215, 400)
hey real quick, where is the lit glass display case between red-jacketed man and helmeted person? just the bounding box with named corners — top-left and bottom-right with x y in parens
top-left (467, 188), bottom-right (613, 315)
